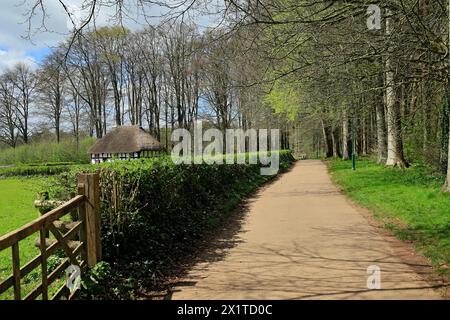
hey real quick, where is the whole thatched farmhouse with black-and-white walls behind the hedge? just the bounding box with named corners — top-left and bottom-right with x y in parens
top-left (88, 126), bottom-right (164, 163)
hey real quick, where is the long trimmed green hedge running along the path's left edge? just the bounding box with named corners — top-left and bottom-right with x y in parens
top-left (54, 151), bottom-right (294, 264)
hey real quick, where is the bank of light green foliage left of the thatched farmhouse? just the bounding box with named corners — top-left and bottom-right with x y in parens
top-left (0, 138), bottom-right (94, 165)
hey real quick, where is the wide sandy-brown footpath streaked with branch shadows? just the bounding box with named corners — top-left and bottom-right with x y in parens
top-left (171, 161), bottom-right (440, 299)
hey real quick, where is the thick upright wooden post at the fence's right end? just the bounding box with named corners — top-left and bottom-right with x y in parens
top-left (78, 173), bottom-right (102, 267)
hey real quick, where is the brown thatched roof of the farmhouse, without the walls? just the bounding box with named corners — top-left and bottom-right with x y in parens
top-left (88, 126), bottom-right (163, 154)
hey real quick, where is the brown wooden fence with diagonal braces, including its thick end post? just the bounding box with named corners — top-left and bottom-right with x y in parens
top-left (0, 174), bottom-right (102, 300)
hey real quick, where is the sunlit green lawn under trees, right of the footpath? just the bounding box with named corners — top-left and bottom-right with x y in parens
top-left (329, 160), bottom-right (450, 275)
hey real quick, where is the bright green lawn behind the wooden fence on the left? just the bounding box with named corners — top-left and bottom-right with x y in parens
top-left (0, 177), bottom-right (48, 299)
